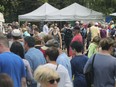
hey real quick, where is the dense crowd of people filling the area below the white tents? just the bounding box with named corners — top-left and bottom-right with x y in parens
top-left (0, 21), bottom-right (116, 87)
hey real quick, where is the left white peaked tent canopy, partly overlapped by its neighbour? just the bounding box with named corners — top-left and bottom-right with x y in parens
top-left (18, 3), bottom-right (58, 21)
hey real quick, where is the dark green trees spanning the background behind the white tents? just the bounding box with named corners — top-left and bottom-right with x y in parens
top-left (0, 0), bottom-right (116, 22)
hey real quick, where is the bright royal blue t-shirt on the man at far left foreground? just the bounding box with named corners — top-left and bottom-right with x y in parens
top-left (0, 52), bottom-right (26, 87)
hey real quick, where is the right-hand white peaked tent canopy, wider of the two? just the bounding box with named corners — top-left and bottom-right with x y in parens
top-left (46, 3), bottom-right (104, 21)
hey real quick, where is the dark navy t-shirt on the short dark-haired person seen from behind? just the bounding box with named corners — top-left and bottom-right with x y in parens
top-left (71, 55), bottom-right (88, 87)
